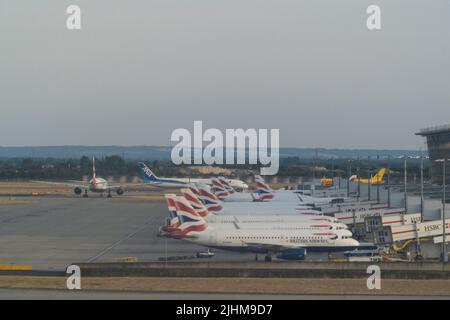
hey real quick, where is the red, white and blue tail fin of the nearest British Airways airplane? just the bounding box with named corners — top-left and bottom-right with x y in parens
top-left (171, 197), bottom-right (208, 238)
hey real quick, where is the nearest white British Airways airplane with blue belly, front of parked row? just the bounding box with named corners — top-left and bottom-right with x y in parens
top-left (171, 198), bottom-right (359, 261)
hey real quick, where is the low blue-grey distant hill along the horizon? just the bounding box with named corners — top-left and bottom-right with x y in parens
top-left (0, 146), bottom-right (420, 161)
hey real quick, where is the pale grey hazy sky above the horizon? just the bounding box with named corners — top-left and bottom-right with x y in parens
top-left (0, 0), bottom-right (450, 149)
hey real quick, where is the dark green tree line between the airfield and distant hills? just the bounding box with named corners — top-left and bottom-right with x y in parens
top-left (0, 155), bottom-right (428, 180)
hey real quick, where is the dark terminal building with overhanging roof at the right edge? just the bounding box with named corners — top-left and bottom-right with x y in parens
top-left (416, 124), bottom-right (450, 184)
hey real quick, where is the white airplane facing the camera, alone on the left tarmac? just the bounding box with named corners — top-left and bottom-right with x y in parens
top-left (33, 158), bottom-right (124, 198)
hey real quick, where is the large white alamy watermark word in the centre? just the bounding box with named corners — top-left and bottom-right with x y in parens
top-left (170, 121), bottom-right (280, 175)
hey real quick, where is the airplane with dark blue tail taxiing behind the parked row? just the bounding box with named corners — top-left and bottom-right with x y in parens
top-left (138, 162), bottom-right (248, 190)
